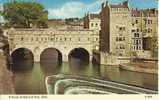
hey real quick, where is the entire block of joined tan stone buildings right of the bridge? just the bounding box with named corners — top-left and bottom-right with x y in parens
top-left (100, 1), bottom-right (158, 57)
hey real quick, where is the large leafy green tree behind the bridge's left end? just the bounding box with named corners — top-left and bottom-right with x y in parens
top-left (3, 0), bottom-right (48, 28)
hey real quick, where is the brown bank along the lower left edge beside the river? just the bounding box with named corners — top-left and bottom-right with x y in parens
top-left (0, 53), bottom-right (15, 94)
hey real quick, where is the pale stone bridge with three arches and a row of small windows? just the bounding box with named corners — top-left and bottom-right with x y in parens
top-left (7, 29), bottom-right (99, 62)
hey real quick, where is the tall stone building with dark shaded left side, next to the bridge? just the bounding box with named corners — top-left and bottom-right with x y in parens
top-left (100, 1), bottom-right (131, 56)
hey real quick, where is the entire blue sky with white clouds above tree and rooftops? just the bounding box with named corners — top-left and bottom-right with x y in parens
top-left (0, 0), bottom-right (158, 19)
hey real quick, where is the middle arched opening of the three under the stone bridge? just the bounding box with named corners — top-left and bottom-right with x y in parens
top-left (40, 48), bottom-right (62, 70)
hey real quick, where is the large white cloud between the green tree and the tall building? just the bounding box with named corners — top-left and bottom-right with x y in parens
top-left (48, 0), bottom-right (102, 18)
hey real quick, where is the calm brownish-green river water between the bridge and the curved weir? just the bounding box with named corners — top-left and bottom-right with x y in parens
top-left (11, 60), bottom-right (158, 94)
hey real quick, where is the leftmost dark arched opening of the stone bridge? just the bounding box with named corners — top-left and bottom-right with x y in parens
top-left (11, 48), bottom-right (34, 71)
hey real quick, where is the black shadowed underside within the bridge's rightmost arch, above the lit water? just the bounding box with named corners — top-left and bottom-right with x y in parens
top-left (68, 47), bottom-right (90, 64)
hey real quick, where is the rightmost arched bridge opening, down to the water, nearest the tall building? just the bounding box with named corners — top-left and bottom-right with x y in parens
top-left (68, 48), bottom-right (90, 66)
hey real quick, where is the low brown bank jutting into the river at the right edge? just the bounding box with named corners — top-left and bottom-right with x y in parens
top-left (120, 62), bottom-right (158, 74)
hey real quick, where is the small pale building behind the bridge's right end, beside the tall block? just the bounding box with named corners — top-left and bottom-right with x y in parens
top-left (84, 13), bottom-right (101, 31)
